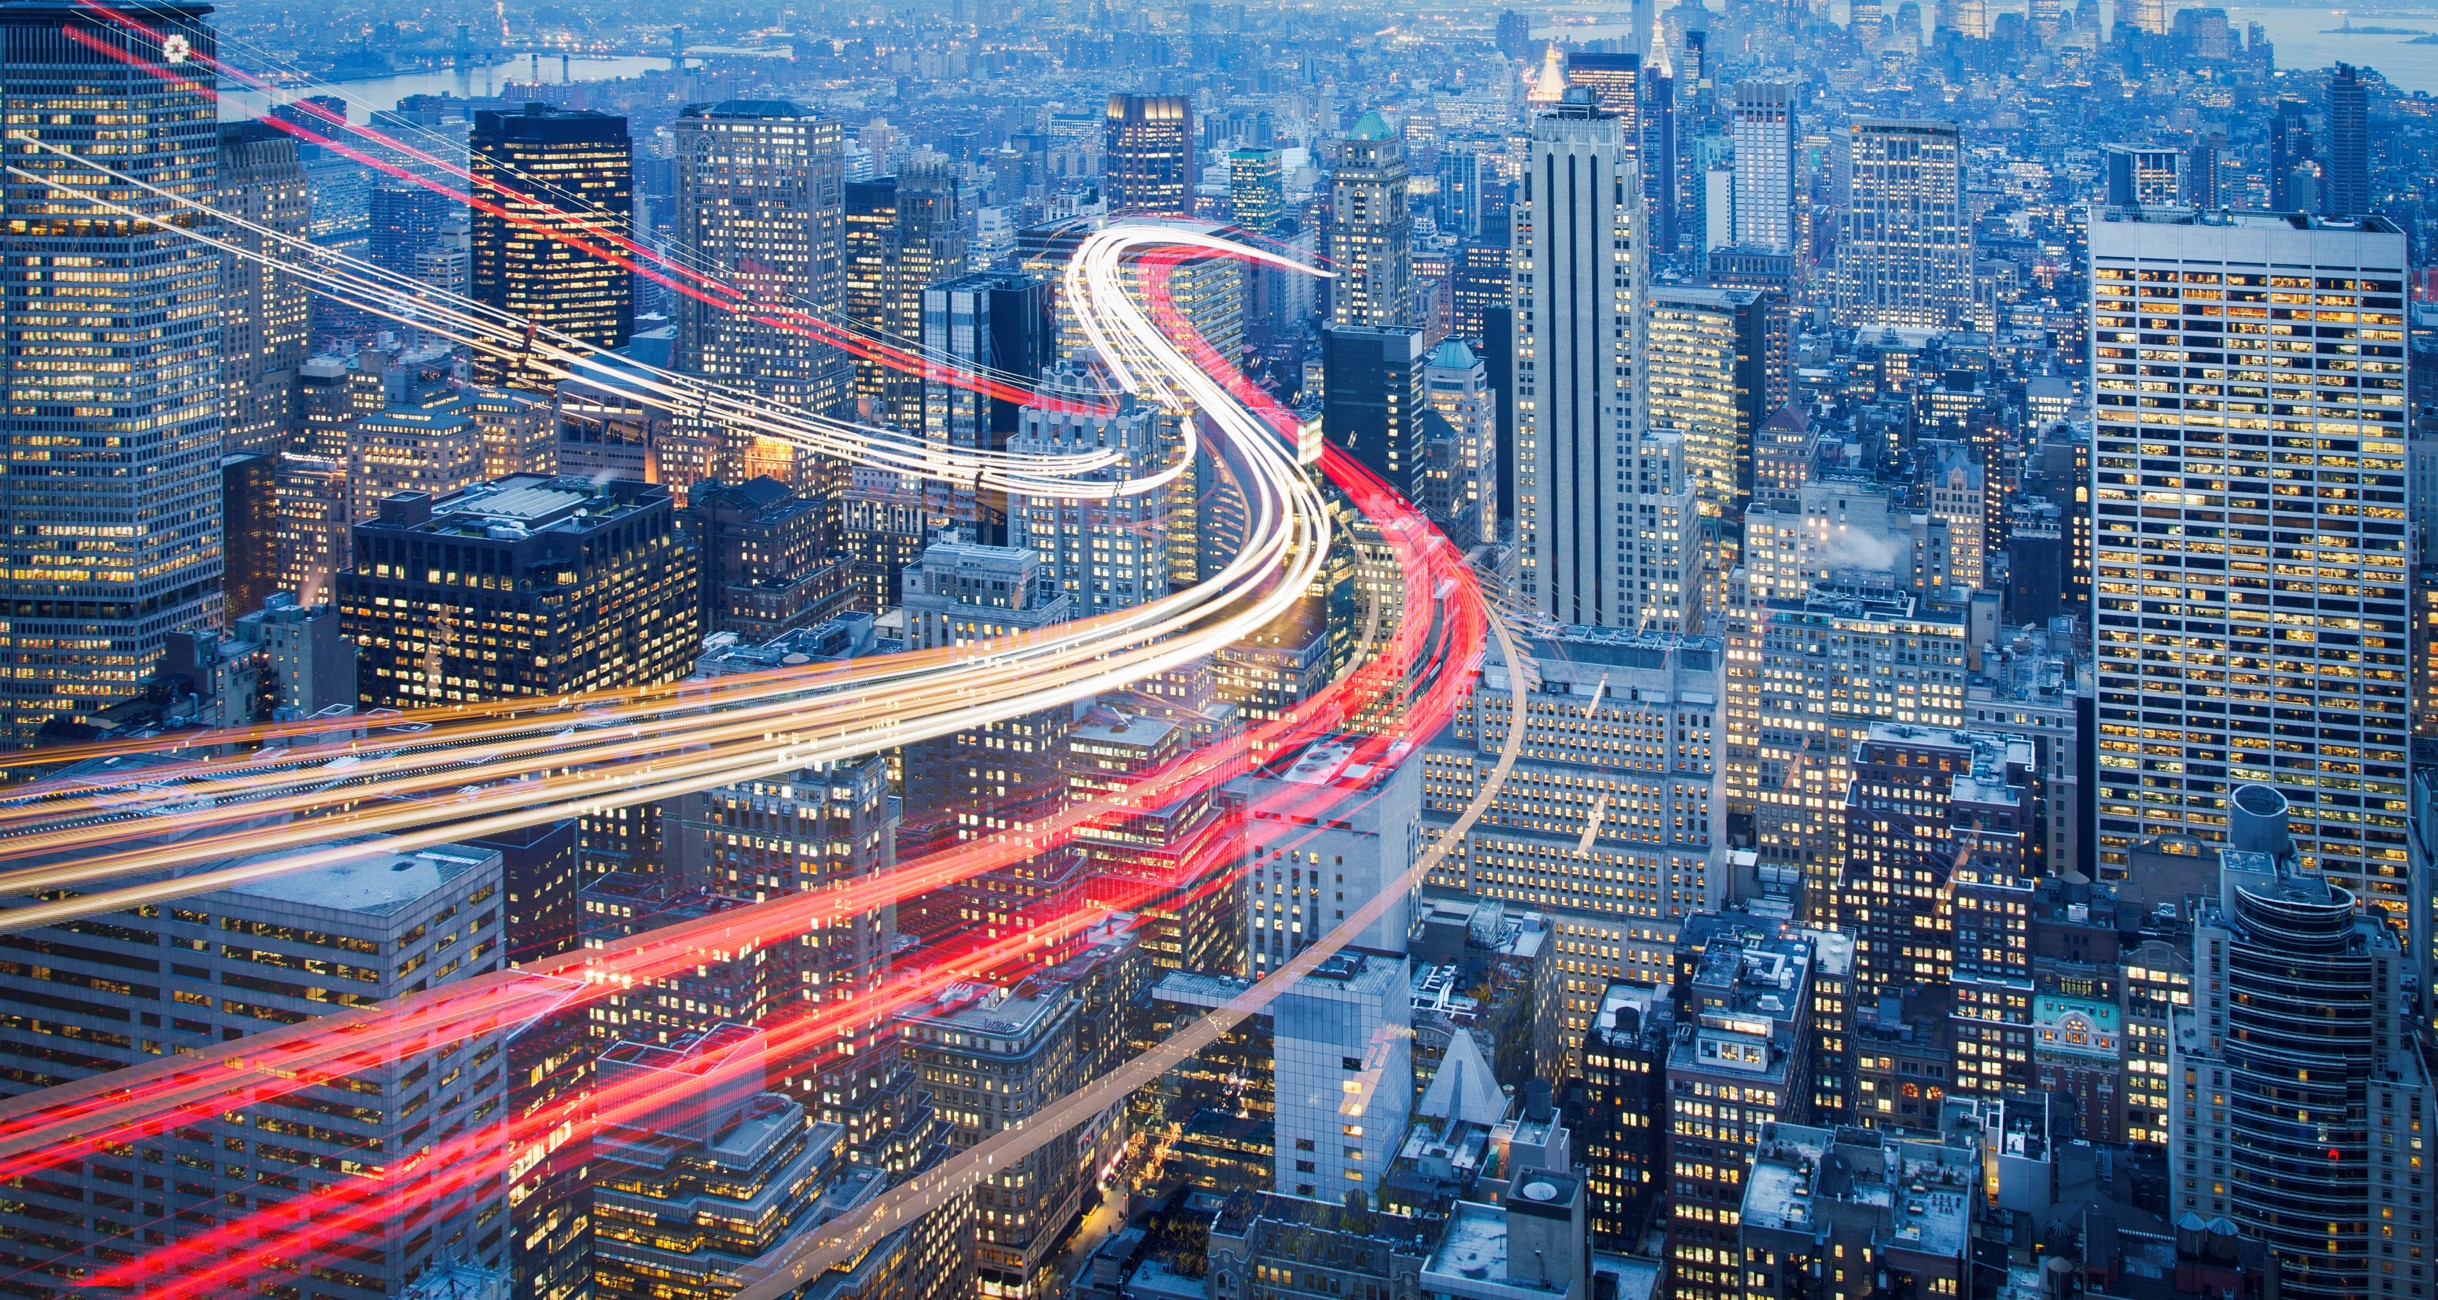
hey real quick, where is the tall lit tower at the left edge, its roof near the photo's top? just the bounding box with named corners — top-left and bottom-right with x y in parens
top-left (0, 2), bottom-right (224, 746)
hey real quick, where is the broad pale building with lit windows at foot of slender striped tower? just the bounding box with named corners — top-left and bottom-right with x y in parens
top-left (1424, 627), bottom-right (1729, 1068)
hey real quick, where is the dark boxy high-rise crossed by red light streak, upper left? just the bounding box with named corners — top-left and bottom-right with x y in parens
top-left (468, 105), bottom-right (634, 393)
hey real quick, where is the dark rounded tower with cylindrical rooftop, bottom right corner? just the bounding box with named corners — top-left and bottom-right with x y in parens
top-left (2167, 780), bottom-right (2438, 1300)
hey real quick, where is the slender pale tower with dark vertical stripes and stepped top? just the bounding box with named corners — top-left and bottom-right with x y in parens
top-left (1512, 88), bottom-right (1648, 627)
